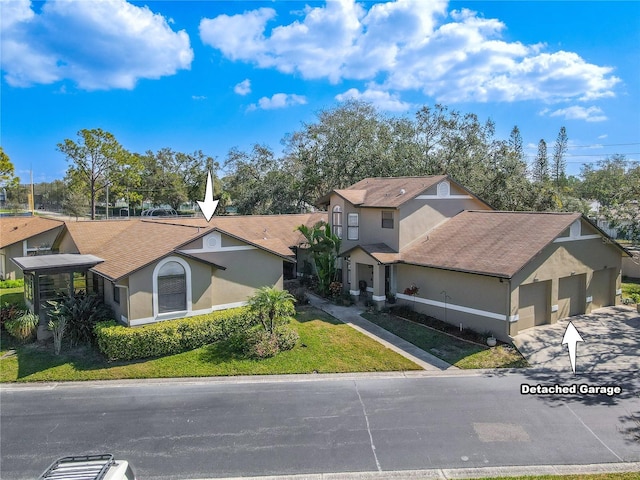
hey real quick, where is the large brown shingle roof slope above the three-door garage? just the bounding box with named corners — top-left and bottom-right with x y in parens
top-left (399, 211), bottom-right (581, 278)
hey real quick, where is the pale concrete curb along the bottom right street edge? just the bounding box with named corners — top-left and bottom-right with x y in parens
top-left (192, 462), bottom-right (640, 480)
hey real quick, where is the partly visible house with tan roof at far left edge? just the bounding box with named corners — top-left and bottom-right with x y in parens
top-left (0, 217), bottom-right (64, 280)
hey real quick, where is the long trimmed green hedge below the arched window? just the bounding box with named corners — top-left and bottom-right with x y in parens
top-left (95, 307), bottom-right (251, 360)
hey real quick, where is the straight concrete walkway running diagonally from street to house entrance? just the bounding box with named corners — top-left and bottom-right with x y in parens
top-left (307, 293), bottom-right (458, 371)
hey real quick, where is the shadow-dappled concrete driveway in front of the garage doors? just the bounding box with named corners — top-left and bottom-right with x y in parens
top-left (513, 306), bottom-right (640, 373)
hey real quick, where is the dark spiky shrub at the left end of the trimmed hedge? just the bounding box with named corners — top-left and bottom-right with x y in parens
top-left (47, 292), bottom-right (113, 346)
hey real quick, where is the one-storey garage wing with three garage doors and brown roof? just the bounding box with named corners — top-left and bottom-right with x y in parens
top-left (382, 210), bottom-right (628, 341)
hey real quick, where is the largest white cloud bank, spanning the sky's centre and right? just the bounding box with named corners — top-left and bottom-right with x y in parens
top-left (200, 0), bottom-right (620, 103)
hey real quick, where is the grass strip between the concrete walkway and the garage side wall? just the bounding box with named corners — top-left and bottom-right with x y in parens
top-left (362, 313), bottom-right (528, 369)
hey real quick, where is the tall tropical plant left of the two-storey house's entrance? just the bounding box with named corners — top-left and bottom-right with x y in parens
top-left (297, 221), bottom-right (342, 295)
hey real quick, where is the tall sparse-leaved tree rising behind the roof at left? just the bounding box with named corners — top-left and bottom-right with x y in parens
top-left (58, 128), bottom-right (132, 220)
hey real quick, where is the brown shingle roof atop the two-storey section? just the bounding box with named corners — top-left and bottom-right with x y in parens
top-left (334, 175), bottom-right (447, 208)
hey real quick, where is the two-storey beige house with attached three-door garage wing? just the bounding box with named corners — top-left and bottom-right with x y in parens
top-left (321, 176), bottom-right (628, 340)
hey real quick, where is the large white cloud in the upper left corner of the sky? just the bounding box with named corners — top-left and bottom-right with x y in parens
top-left (1, 0), bottom-right (193, 90)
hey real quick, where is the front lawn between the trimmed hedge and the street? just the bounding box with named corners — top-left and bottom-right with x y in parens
top-left (0, 308), bottom-right (420, 382)
